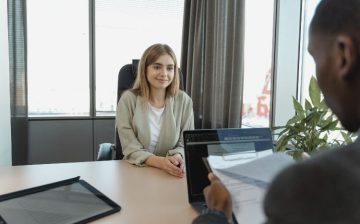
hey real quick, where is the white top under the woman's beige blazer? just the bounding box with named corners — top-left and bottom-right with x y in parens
top-left (149, 103), bottom-right (165, 153)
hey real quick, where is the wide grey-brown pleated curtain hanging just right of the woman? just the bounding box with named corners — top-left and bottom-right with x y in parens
top-left (181, 0), bottom-right (245, 128)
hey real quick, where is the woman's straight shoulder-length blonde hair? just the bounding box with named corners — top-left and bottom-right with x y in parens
top-left (132, 44), bottom-right (180, 100)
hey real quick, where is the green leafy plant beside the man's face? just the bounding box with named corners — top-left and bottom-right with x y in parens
top-left (274, 77), bottom-right (355, 159)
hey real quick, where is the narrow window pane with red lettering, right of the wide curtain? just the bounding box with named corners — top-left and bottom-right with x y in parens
top-left (242, 0), bottom-right (274, 127)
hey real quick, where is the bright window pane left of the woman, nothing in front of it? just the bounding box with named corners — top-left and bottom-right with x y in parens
top-left (27, 0), bottom-right (90, 116)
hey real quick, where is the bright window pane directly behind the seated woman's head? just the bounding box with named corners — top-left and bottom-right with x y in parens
top-left (95, 0), bottom-right (184, 116)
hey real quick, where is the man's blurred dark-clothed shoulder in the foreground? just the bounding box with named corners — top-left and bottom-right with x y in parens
top-left (264, 142), bottom-right (360, 223)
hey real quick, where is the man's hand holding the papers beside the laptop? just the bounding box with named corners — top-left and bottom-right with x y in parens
top-left (204, 173), bottom-right (232, 220)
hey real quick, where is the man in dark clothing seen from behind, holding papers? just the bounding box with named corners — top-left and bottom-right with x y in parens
top-left (194, 0), bottom-right (360, 224)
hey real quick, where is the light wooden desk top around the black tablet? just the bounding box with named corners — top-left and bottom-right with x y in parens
top-left (0, 160), bottom-right (197, 224)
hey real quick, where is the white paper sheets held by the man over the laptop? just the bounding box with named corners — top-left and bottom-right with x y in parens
top-left (208, 151), bottom-right (294, 224)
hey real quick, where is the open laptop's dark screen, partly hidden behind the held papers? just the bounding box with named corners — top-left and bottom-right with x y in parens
top-left (184, 128), bottom-right (273, 203)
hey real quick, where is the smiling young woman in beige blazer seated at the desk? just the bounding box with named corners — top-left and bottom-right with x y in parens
top-left (116, 44), bottom-right (194, 177)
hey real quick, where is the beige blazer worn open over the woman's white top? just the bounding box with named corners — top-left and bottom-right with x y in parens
top-left (116, 90), bottom-right (194, 166)
